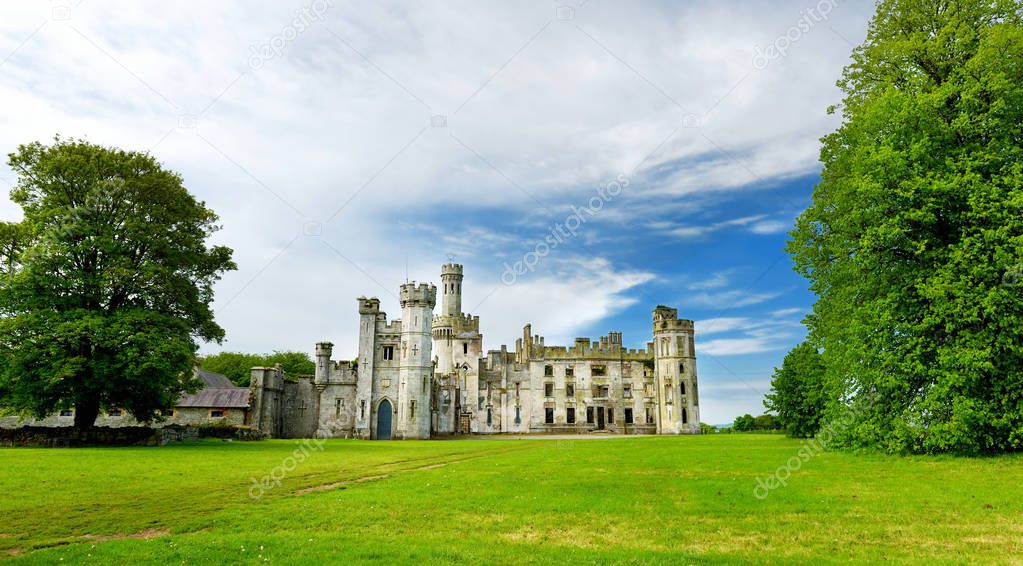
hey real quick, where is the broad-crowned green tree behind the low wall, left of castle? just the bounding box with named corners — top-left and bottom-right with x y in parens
top-left (0, 138), bottom-right (234, 428)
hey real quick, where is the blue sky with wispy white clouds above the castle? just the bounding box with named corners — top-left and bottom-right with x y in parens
top-left (0, 0), bottom-right (873, 423)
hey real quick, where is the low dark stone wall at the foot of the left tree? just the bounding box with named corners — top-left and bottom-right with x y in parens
top-left (0, 425), bottom-right (267, 448)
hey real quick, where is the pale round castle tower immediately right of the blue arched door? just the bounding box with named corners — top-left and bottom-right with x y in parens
top-left (394, 280), bottom-right (435, 438)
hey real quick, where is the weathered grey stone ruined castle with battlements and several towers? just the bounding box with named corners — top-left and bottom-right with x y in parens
top-left (248, 263), bottom-right (700, 439)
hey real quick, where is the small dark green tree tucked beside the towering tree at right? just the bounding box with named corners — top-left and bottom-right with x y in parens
top-left (764, 342), bottom-right (830, 438)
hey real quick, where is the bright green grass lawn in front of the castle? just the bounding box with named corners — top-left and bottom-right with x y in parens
top-left (0, 435), bottom-right (1023, 564)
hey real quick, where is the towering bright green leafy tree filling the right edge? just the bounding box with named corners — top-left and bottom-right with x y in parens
top-left (789, 0), bottom-right (1023, 452)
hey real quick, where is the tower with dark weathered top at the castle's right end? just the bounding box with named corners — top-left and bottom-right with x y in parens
top-left (654, 306), bottom-right (700, 434)
